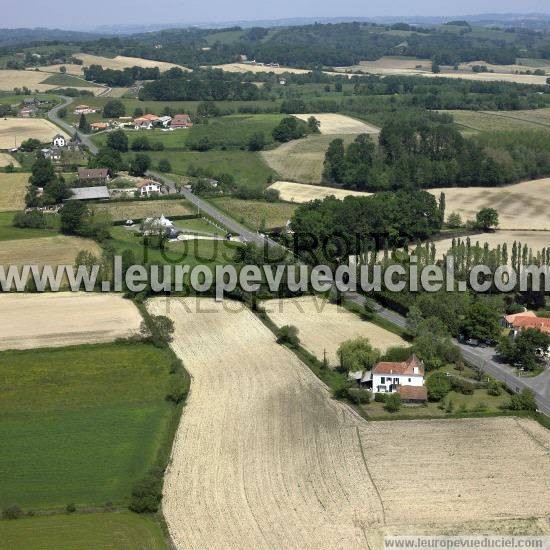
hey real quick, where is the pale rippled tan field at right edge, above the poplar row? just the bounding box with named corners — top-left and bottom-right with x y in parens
top-left (428, 178), bottom-right (550, 230)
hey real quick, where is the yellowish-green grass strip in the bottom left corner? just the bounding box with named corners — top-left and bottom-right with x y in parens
top-left (0, 512), bottom-right (166, 550)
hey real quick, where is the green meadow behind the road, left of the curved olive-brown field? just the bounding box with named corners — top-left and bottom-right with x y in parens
top-left (143, 150), bottom-right (276, 190)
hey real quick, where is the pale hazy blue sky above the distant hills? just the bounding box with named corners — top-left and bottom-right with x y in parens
top-left (0, 0), bottom-right (550, 30)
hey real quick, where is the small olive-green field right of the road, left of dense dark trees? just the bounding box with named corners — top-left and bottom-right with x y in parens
top-left (209, 197), bottom-right (296, 229)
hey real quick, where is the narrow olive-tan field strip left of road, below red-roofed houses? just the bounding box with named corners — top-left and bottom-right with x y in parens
top-left (93, 199), bottom-right (195, 221)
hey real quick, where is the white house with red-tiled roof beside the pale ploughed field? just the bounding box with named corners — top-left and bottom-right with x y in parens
top-left (348, 355), bottom-right (428, 403)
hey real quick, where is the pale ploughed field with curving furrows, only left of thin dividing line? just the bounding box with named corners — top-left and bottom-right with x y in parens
top-left (147, 298), bottom-right (382, 550)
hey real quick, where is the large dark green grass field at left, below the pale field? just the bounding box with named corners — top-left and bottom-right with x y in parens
top-left (0, 343), bottom-right (184, 511)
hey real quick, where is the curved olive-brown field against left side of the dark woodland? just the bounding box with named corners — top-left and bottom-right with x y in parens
top-left (261, 134), bottom-right (354, 183)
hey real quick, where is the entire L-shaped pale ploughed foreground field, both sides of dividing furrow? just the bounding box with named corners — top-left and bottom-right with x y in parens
top-left (147, 298), bottom-right (550, 550)
